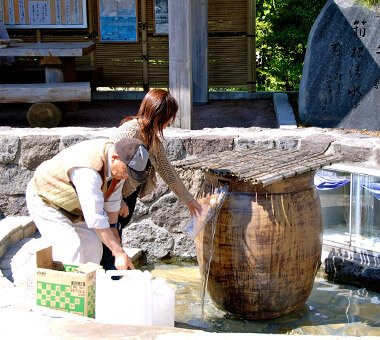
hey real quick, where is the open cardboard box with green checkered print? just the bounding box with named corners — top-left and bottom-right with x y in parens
top-left (36, 247), bottom-right (102, 318)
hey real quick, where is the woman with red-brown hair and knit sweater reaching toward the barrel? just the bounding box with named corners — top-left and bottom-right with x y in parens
top-left (101, 89), bottom-right (202, 269)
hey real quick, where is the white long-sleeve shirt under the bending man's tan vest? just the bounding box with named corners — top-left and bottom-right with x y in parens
top-left (69, 168), bottom-right (124, 229)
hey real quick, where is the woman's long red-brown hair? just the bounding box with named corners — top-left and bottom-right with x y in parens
top-left (120, 89), bottom-right (178, 148)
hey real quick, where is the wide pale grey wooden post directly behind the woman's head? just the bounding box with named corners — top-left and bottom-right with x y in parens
top-left (169, 0), bottom-right (191, 129)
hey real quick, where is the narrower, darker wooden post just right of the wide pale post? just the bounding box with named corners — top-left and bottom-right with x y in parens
top-left (192, 0), bottom-right (208, 104)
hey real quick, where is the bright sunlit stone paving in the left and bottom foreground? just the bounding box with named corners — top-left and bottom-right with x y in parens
top-left (0, 217), bottom-right (376, 340)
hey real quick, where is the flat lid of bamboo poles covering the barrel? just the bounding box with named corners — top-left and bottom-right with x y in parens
top-left (173, 146), bottom-right (340, 186)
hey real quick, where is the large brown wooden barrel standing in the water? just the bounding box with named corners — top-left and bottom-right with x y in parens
top-left (195, 172), bottom-right (322, 319)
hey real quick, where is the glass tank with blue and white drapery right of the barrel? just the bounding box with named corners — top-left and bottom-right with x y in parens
top-left (315, 169), bottom-right (380, 252)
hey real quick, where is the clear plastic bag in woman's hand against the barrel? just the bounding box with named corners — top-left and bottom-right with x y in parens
top-left (182, 183), bottom-right (228, 240)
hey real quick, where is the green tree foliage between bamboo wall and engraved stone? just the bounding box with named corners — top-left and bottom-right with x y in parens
top-left (256, 0), bottom-right (326, 91)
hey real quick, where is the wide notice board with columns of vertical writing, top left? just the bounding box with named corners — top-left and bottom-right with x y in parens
top-left (0, 0), bottom-right (87, 28)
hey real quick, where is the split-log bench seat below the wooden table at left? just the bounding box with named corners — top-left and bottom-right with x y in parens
top-left (0, 82), bottom-right (91, 103)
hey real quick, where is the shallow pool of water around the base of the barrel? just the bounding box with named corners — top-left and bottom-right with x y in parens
top-left (150, 263), bottom-right (380, 336)
